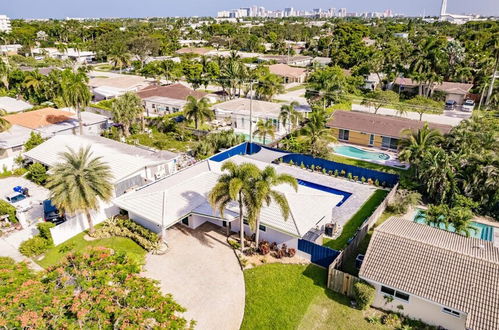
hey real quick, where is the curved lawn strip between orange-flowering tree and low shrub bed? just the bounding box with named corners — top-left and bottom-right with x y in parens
top-left (36, 232), bottom-right (146, 268)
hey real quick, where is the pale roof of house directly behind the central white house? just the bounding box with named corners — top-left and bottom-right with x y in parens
top-left (213, 98), bottom-right (282, 118)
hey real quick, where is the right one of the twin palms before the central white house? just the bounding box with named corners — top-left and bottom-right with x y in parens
top-left (248, 166), bottom-right (298, 248)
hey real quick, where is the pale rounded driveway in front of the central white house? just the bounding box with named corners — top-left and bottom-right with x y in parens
top-left (143, 223), bottom-right (245, 330)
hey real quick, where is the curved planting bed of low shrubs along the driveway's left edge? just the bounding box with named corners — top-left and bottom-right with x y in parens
top-left (94, 218), bottom-right (160, 251)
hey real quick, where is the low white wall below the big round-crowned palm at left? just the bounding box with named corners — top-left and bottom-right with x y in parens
top-left (50, 204), bottom-right (119, 245)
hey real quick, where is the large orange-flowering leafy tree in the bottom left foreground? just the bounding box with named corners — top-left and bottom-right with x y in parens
top-left (0, 247), bottom-right (193, 329)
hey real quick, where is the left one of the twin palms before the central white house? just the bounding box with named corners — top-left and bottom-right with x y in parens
top-left (208, 161), bottom-right (260, 252)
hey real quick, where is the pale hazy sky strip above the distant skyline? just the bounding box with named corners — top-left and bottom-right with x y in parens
top-left (0, 0), bottom-right (499, 18)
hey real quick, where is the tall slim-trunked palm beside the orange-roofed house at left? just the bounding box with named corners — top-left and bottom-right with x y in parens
top-left (61, 69), bottom-right (92, 135)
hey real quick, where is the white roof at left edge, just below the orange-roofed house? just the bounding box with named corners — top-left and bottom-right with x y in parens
top-left (0, 125), bottom-right (32, 170)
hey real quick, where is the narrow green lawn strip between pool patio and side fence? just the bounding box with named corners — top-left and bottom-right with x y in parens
top-left (324, 189), bottom-right (388, 250)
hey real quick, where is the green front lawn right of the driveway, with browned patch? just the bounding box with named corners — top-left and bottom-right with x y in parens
top-left (241, 264), bottom-right (386, 330)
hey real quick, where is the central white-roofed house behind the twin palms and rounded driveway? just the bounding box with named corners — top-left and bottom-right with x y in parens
top-left (114, 155), bottom-right (342, 249)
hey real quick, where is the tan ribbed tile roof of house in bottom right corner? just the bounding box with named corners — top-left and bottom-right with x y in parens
top-left (359, 218), bottom-right (499, 329)
